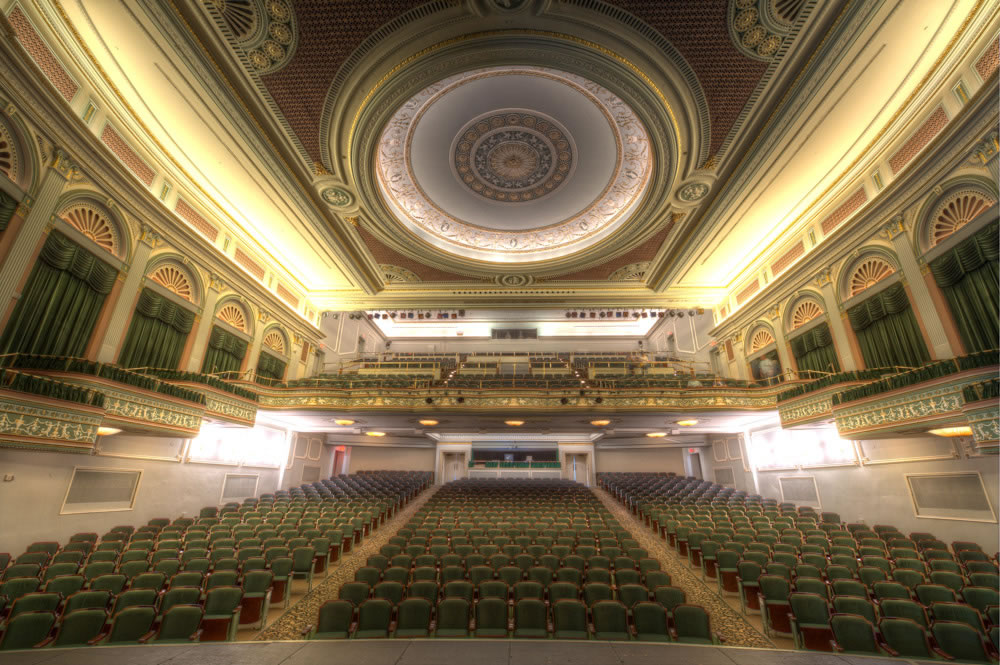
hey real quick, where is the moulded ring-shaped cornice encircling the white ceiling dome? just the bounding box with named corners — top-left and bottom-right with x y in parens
top-left (350, 30), bottom-right (679, 278)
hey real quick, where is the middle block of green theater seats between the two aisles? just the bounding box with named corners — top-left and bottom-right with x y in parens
top-left (305, 480), bottom-right (719, 644)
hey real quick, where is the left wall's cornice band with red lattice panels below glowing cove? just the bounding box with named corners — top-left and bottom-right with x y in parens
top-left (0, 32), bottom-right (323, 341)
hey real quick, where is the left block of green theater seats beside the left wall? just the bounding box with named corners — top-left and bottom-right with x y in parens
top-left (0, 471), bottom-right (431, 651)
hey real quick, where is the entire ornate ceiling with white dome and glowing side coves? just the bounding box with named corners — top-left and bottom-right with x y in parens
top-left (15, 0), bottom-right (997, 309)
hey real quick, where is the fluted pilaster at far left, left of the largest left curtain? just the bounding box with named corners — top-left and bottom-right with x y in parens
top-left (0, 149), bottom-right (77, 326)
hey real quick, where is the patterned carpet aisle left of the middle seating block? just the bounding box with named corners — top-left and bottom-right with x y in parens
top-left (253, 485), bottom-right (441, 641)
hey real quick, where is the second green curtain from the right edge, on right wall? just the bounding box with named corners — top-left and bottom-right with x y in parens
top-left (847, 283), bottom-right (931, 368)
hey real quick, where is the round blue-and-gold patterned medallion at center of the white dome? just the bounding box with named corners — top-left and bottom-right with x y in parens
top-left (452, 109), bottom-right (574, 203)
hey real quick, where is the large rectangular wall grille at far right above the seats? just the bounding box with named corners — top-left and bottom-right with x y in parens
top-left (906, 472), bottom-right (996, 522)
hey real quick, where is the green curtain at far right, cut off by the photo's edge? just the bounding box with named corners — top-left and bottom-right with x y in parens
top-left (931, 222), bottom-right (1000, 353)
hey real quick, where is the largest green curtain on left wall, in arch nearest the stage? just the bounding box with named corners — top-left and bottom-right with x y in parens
top-left (0, 231), bottom-right (118, 357)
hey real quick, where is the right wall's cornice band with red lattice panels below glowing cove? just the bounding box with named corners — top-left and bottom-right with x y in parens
top-left (709, 83), bottom-right (1000, 339)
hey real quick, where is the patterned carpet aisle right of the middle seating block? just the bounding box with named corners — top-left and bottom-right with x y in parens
top-left (591, 487), bottom-right (775, 649)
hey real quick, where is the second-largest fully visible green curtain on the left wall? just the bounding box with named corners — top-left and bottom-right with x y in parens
top-left (118, 289), bottom-right (194, 369)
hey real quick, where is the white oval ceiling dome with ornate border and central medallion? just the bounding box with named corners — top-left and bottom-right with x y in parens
top-left (375, 66), bottom-right (654, 264)
